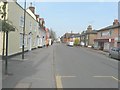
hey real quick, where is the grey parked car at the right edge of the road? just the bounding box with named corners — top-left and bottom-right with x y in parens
top-left (109, 47), bottom-right (120, 60)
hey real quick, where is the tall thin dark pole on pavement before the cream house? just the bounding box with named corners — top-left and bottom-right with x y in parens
top-left (22, 0), bottom-right (26, 59)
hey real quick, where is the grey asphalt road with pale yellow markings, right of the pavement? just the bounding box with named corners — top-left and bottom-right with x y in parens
top-left (54, 44), bottom-right (118, 88)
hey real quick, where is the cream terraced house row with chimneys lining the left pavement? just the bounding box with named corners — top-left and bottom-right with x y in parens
top-left (0, 1), bottom-right (46, 55)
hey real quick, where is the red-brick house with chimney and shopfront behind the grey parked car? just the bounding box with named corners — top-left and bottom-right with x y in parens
top-left (94, 19), bottom-right (120, 51)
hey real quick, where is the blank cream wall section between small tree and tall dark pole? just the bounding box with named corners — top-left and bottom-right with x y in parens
top-left (8, 2), bottom-right (26, 55)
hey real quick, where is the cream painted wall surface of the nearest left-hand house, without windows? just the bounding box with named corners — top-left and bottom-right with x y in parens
top-left (8, 2), bottom-right (38, 55)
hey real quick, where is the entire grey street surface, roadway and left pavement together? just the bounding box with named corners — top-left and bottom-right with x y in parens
top-left (2, 43), bottom-right (119, 88)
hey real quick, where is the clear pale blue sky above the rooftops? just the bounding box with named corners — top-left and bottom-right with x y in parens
top-left (17, 0), bottom-right (118, 37)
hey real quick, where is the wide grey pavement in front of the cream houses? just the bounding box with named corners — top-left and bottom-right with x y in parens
top-left (2, 46), bottom-right (56, 88)
